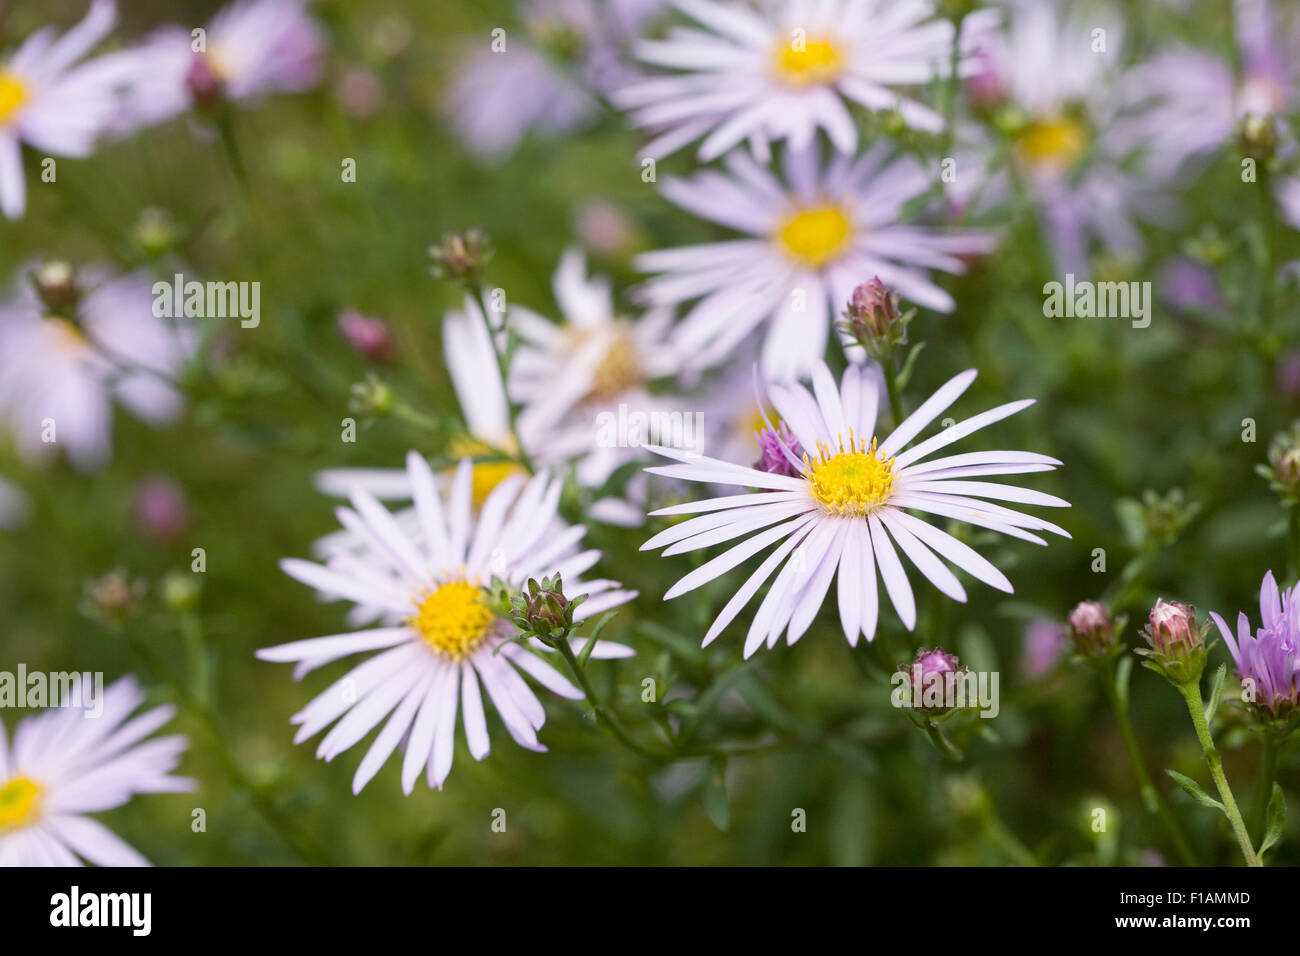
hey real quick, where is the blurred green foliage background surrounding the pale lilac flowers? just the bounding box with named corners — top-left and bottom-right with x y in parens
top-left (0, 0), bottom-right (1300, 865)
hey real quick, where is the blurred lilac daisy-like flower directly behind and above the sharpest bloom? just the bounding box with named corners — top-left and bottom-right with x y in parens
top-left (636, 142), bottom-right (995, 381)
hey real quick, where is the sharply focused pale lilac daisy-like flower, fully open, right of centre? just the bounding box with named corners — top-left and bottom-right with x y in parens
top-left (641, 363), bottom-right (1069, 657)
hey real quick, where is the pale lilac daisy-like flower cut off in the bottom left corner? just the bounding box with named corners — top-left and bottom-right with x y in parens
top-left (0, 678), bottom-right (194, 866)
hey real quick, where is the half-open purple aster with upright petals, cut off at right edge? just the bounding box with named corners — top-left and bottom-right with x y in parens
top-left (1210, 571), bottom-right (1300, 717)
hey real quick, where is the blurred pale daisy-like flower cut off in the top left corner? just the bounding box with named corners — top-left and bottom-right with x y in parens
top-left (0, 0), bottom-right (120, 219)
